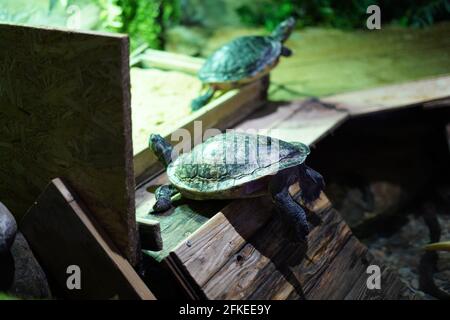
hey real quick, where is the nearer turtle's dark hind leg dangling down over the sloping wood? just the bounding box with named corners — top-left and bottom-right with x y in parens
top-left (269, 173), bottom-right (309, 242)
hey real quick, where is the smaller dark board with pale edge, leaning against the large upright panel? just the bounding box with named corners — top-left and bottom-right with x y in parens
top-left (20, 179), bottom-right (155, 300)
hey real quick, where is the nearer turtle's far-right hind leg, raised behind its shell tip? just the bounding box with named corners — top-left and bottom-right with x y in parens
top-left (298, 164), bottom-right (325, 204)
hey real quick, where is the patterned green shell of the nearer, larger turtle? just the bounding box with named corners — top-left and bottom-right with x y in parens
top-left (167, 132), bottom-right (309, 200)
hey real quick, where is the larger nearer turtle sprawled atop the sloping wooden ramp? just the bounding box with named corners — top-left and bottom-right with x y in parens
top-left (149, 131), bottom-right (325, 242)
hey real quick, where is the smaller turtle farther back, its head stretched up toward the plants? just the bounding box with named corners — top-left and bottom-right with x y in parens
top-left (191, 17), bottom-right (295, 111)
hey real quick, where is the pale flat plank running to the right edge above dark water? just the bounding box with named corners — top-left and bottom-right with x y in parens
top-left (321, 76), bottom-right (450, 116)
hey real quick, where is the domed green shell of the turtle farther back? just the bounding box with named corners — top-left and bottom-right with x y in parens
top-left (198, 36), bottom-right (282, 83)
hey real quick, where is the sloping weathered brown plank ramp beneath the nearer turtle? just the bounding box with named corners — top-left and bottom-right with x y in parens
top-left (167, 188), bottom-right (403, 300)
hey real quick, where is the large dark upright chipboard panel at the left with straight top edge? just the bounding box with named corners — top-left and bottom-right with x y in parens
top-left (0, 25), bottom-right (137, 263)
